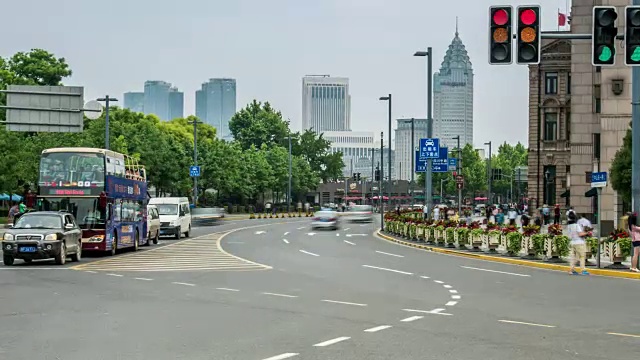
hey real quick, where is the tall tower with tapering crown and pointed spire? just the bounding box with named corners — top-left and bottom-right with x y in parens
top-left (433, 18), bottom-right (473, 149)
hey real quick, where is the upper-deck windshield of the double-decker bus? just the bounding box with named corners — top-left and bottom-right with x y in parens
top-left (38, 152), bottom-right (105, 187)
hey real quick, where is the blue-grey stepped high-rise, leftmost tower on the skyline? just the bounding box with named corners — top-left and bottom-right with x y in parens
top-left (136, 80), bottom-right (184, 121)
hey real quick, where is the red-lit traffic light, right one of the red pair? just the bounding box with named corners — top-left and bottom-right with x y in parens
top-left (516, 5), bottom-right (540, 64)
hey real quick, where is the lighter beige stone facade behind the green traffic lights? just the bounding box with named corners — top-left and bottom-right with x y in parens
top-left (570, 0), bottom-right (631, 233)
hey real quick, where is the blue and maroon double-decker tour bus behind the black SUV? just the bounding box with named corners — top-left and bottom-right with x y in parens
top-left (38, 147), bottom-right (149, 255)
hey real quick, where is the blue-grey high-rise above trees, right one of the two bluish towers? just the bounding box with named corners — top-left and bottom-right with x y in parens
top-left (196, 78), bottom-right (236, 140)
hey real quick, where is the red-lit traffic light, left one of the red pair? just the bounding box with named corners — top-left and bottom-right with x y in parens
top-left (489, 6), bottom-right (513, 65)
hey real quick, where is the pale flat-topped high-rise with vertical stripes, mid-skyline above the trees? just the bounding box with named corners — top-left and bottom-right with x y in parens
top-left (302, 75), bottom-right (351, 133)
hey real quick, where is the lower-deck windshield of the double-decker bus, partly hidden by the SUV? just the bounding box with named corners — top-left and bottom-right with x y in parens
top-left (41, 197), bottom-right (107, 229)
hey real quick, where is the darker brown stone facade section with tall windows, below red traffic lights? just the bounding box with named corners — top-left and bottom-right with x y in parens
top-left (527, 35), bottom-right (572, 207)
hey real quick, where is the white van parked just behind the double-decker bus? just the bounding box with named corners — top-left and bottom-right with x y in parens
top-left (149, 197), bottom-right (191, 239)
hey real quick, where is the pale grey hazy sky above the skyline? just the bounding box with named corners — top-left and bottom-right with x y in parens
top-left (0, 0), bottom-right (566, 147)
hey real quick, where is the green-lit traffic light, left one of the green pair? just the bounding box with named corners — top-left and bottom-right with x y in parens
top-left (591, 6), bottom-right (618, 66)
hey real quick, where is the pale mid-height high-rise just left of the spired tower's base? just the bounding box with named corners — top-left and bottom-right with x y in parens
top-left (394, 119), bottom-right (428, 180)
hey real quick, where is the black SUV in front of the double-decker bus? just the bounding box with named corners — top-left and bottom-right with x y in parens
top-left (2, 211), bottom-right (82, 266)
